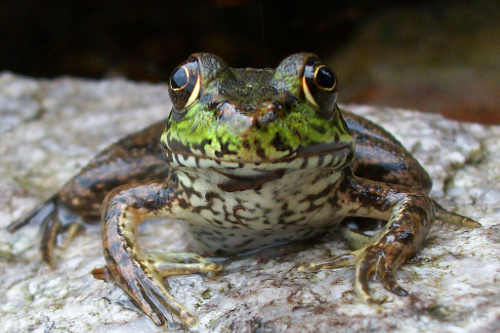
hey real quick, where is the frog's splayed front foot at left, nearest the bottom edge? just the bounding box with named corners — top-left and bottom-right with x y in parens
top-left (92, 251), bottom-right (222, 326)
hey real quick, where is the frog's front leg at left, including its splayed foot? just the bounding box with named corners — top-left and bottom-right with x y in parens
top-left (92, 183), bottom-right (222, 326)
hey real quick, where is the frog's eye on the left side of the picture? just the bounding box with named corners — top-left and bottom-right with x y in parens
top-left (168, 61), bottom-right (201, 113)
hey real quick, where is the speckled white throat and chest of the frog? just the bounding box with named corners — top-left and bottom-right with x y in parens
top-left (173, 168), bottom-right (343, 252)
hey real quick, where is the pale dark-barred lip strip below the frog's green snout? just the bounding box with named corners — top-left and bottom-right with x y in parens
top-left (165, 147), bottom-right (352, 176)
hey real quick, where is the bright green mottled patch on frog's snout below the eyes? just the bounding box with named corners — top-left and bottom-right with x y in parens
top-left (162, 104), bottom-right (353, 163)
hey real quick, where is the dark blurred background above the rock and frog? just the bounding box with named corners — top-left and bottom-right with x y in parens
top-left (0, 0), bottom-right (500, 124)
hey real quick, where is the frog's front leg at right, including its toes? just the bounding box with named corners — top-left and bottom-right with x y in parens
top-left (301, 175), bottom-right (436, 304)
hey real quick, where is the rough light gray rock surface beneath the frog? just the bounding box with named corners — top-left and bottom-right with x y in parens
top-left (0, 73), bottom-right (500, 332)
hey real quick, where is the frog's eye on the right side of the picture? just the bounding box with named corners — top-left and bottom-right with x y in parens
top-left (302, 57), bottom-right (337, 115)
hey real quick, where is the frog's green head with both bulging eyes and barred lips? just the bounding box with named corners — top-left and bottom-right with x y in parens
top-left (161, 53), bottom-right (353, 172)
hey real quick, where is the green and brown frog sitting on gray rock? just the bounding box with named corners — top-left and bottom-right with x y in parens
top-left (8, 53), bottom-right (481, 326)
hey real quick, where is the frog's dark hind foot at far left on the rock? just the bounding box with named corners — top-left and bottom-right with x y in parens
top-left (7, 195), bottom-right (82, 267)
